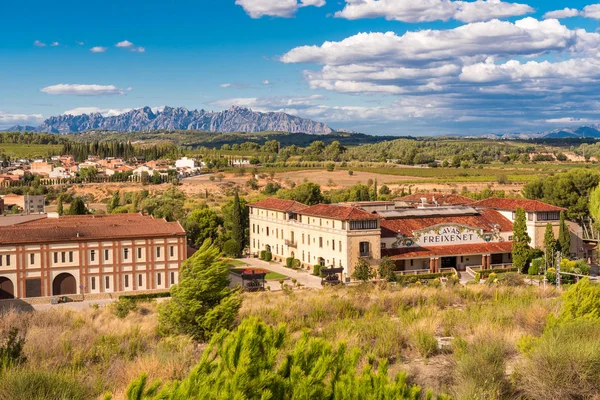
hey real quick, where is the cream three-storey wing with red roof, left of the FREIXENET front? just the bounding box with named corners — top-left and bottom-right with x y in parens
top-left (248, 199), bottom-right (381, 277)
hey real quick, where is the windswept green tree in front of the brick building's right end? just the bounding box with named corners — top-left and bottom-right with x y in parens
top-left (159, 240), bottom-right (241, 341)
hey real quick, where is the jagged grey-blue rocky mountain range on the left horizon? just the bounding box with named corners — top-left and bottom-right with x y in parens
top-left (7, 106), bottom-right (334, 134)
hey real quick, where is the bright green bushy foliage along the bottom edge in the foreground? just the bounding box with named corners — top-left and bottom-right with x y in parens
top-left (127, 318), bottom-right (442, 400)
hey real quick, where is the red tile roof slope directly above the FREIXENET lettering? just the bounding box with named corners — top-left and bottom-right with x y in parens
top-left (381, 210), bottom-right (513, 237)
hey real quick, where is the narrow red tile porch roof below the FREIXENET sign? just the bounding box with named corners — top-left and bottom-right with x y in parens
top-left (381, 242), bottom-right (513, 260)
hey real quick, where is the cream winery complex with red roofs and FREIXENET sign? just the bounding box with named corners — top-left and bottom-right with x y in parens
top-left (249, 194), bottom-right (585, 277)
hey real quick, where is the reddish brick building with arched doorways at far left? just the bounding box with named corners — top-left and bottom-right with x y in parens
top-left (0, 214), bottom-right (186, 299)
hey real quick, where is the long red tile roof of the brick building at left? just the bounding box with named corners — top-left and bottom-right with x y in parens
top-left (0, 214), bottom-right (185, 245)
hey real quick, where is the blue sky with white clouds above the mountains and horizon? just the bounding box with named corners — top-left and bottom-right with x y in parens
top-left (0, 0), bottom-right (600, 135)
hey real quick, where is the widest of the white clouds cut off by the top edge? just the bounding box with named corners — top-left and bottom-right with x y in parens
top-left (335, 0), bottom-right (534, 22)
